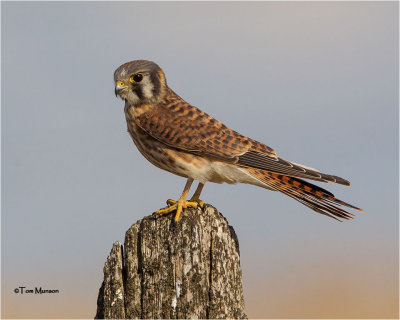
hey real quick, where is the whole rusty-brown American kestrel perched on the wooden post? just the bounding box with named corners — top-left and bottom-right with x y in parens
top-left (114, 60), bottom-right (361, 221)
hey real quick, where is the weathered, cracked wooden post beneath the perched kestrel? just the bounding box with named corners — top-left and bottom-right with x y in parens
top-left (95, 205), bottom-right (246, 319)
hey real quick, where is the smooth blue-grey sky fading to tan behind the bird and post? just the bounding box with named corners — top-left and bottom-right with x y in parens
top-left (1, 2), bottom-right (399, 318)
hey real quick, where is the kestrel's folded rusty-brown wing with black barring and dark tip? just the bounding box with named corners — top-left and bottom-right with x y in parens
top-left (135, 97), bottom-right (350, 185)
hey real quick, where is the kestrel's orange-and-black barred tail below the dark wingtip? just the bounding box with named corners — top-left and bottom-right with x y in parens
top-left (242, 168), bottom-right (362, 221)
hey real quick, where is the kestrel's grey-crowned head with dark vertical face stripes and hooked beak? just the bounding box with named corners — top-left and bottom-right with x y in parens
top-left (114, 60), bottom-right (167, 106)
